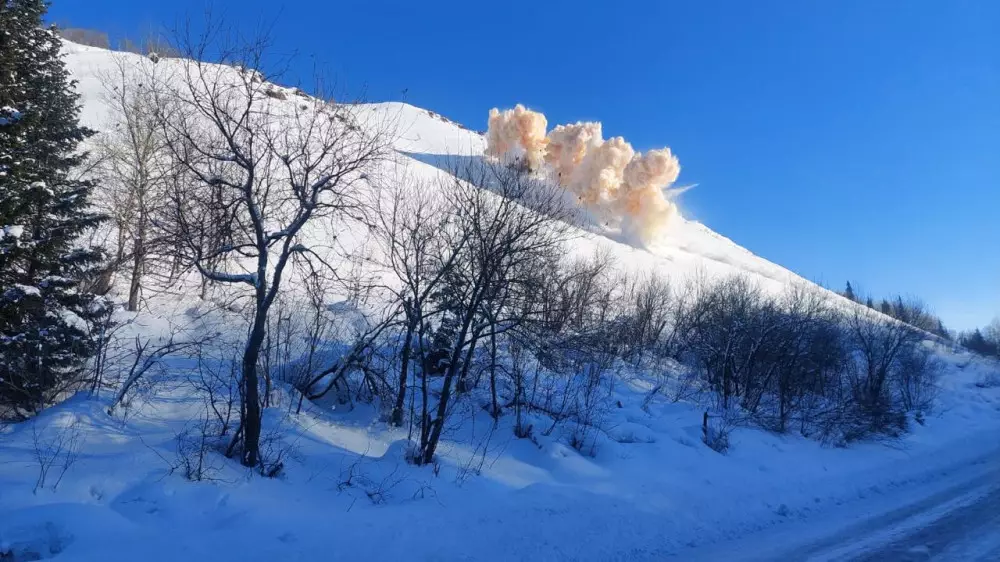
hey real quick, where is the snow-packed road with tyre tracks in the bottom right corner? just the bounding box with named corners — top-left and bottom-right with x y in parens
top-left (680, 451), bottom-right (1000, 562)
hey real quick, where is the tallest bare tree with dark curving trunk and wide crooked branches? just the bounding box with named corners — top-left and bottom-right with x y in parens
top-left (159, 26), bottom-right (389, 466)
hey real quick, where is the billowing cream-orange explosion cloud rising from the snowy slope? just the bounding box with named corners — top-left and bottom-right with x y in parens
top-left (486, 104), bottom-right (681, 242)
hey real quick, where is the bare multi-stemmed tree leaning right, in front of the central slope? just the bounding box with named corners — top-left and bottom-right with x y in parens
top-left (414, 160), bottom-right (574, 464)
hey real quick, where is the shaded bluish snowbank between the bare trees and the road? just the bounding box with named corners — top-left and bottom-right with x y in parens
top-left (0, 344), bottom-right (1000, 560)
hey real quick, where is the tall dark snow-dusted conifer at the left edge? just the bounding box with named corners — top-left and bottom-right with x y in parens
top-left (0, 0), bottom-right (108, 415)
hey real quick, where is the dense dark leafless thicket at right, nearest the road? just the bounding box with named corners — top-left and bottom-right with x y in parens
top-left (686, 277), bottom-right (936, 442)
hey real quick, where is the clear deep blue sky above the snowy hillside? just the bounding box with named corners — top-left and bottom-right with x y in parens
top-left (50, 0), bottom-right (1000, 328)
